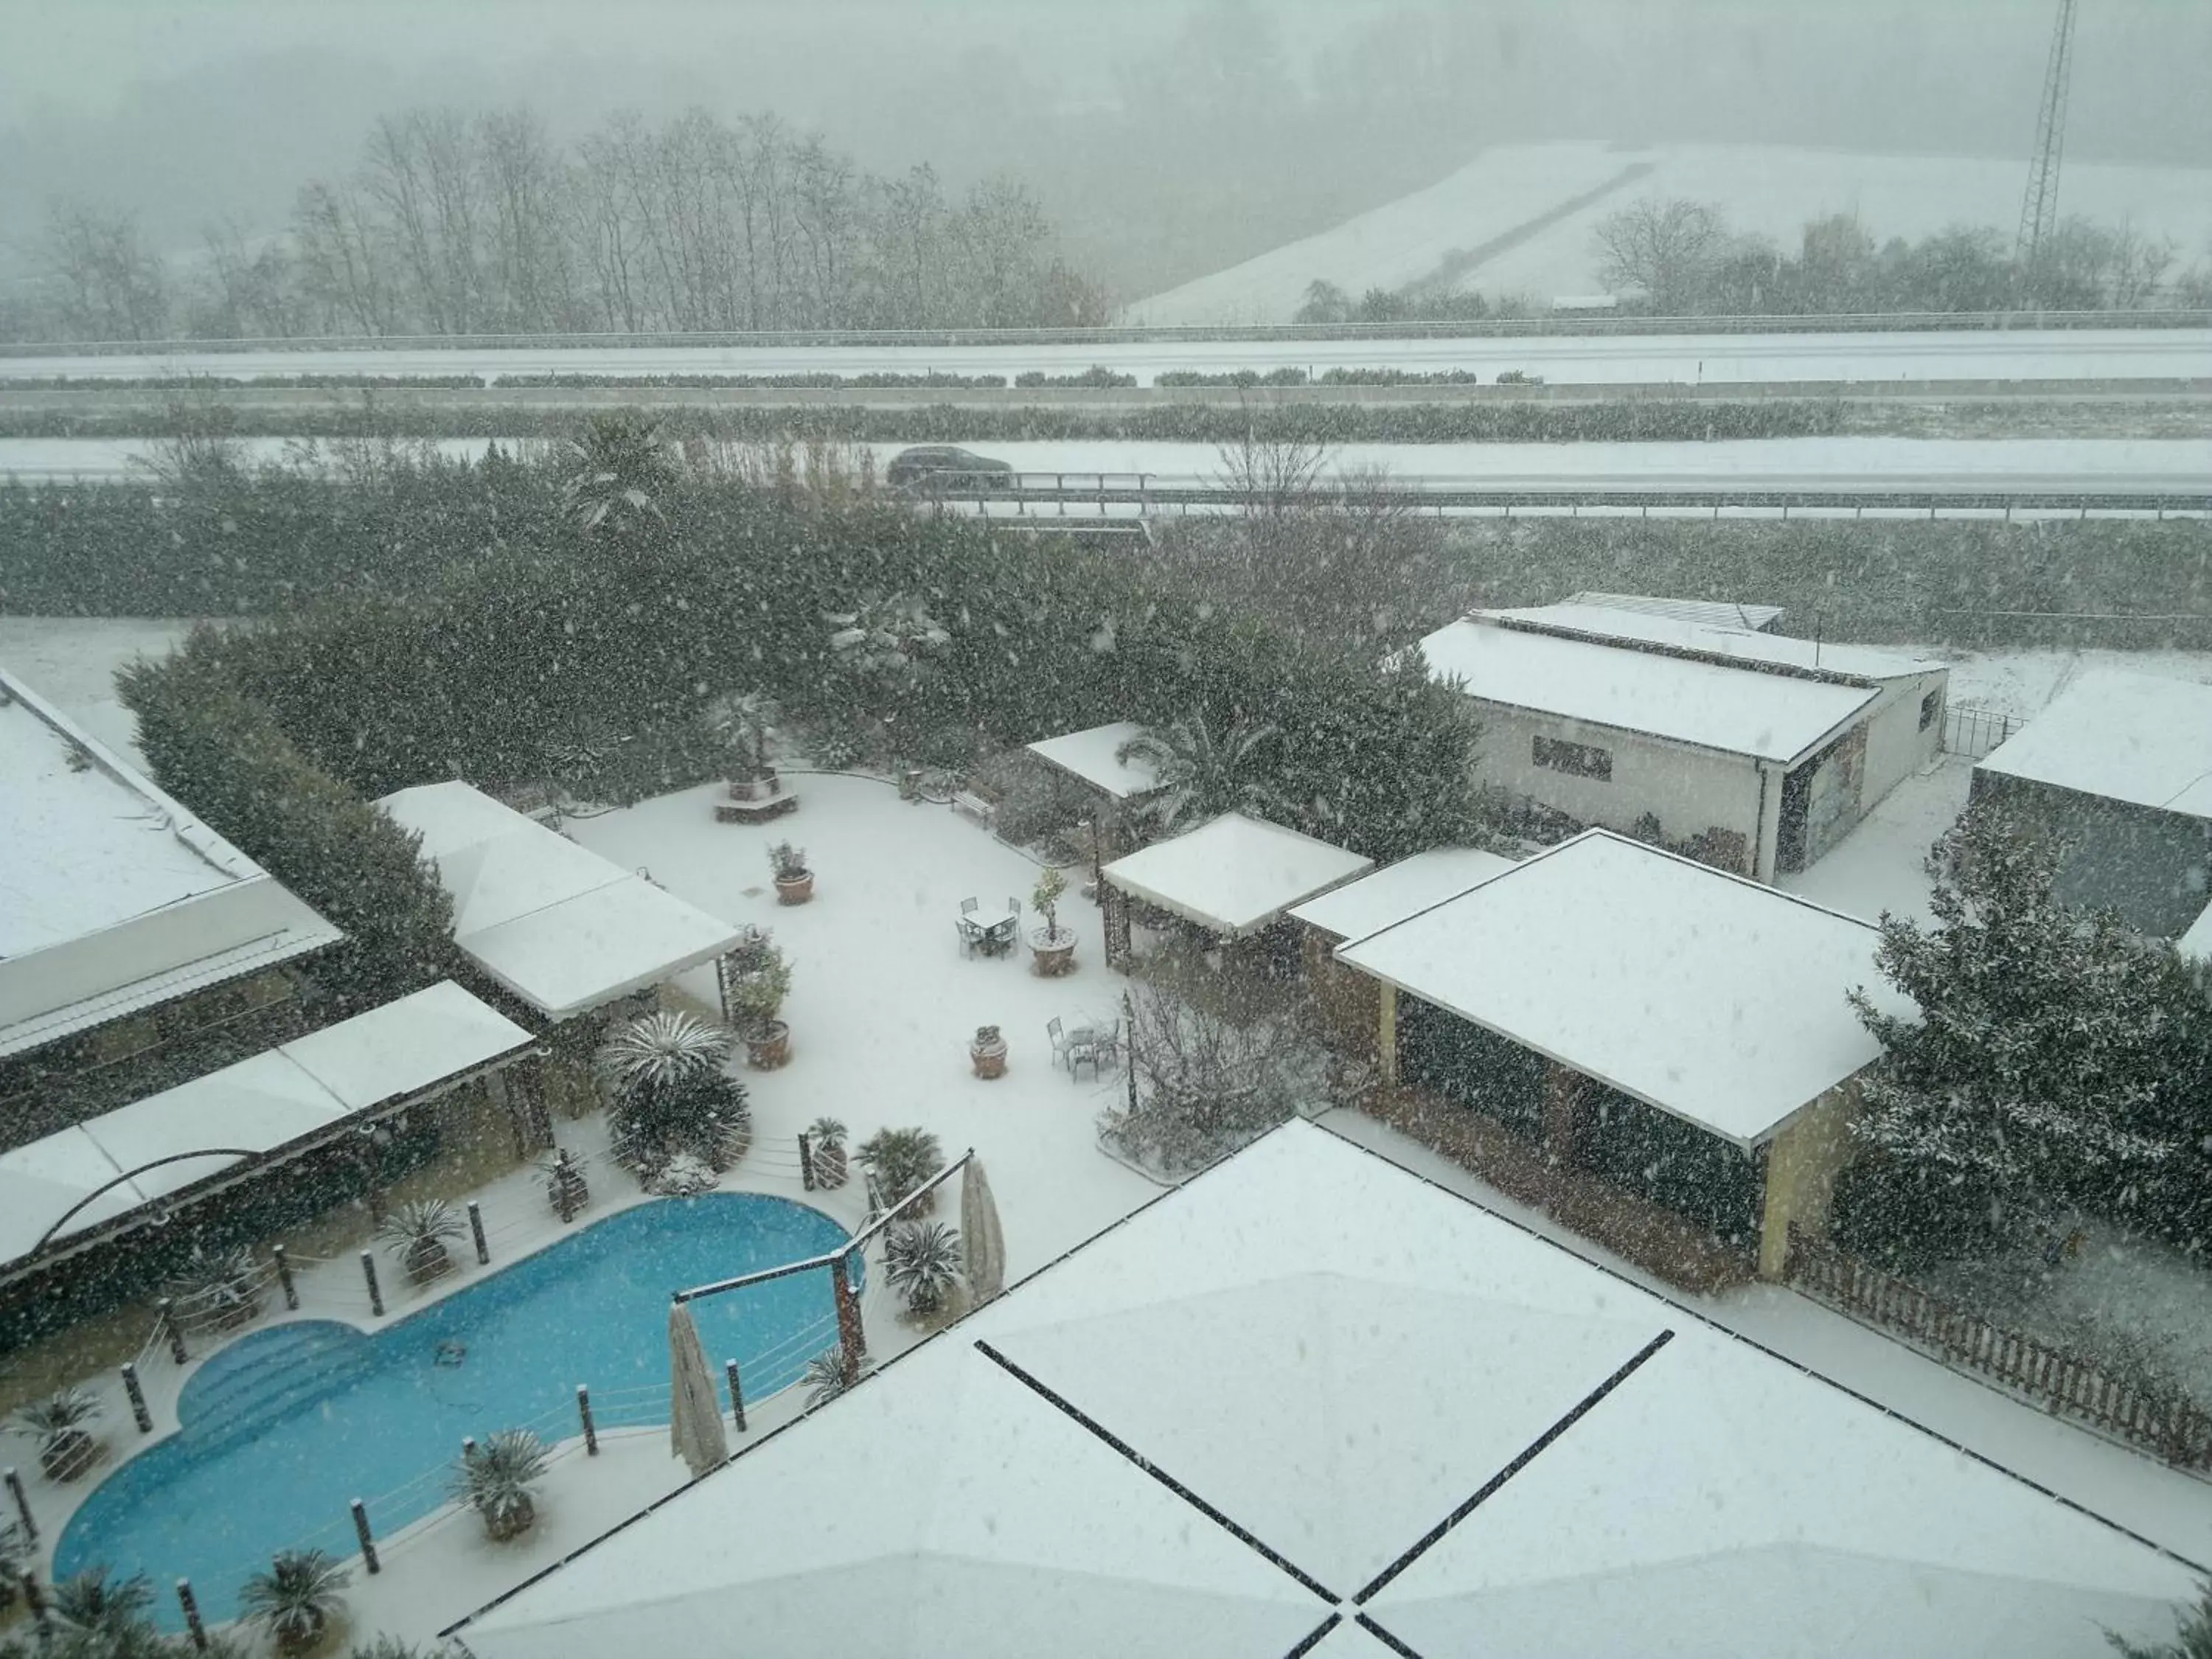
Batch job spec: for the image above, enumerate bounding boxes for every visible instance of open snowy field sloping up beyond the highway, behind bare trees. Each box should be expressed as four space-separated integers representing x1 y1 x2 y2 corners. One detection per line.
1130 144 2212 325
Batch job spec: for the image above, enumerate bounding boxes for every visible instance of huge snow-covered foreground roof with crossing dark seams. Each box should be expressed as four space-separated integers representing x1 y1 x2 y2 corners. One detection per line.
456 1121 2194 1659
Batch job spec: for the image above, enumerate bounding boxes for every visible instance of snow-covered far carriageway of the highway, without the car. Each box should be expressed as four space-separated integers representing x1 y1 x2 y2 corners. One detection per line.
13 327 2212 387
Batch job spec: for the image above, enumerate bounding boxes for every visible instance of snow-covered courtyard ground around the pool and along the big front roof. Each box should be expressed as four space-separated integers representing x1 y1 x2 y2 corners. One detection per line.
4 772 2212 1641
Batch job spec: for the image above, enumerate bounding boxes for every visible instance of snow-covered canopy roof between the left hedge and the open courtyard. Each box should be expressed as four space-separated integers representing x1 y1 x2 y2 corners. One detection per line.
376 781 739 1020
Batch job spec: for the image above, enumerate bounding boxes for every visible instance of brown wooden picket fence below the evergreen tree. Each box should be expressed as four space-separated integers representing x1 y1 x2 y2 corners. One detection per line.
1787 1225 2212 1469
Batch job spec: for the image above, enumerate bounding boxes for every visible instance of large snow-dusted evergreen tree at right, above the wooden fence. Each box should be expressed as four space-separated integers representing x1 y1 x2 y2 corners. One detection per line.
1851 807 2212 1212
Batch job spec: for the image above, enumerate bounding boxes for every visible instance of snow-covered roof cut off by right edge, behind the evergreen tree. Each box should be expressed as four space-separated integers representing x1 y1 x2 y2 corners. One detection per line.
1975 670 2212 818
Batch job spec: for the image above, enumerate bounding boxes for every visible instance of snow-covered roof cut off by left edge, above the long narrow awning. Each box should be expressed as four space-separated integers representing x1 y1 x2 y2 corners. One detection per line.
0 672 343 1055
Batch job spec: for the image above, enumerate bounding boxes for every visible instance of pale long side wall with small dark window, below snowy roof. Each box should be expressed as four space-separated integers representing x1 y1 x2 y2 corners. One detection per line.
1471 697 1759 876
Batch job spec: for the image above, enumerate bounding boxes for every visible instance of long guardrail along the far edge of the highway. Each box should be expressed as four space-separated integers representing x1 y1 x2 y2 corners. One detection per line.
0 310 2212 358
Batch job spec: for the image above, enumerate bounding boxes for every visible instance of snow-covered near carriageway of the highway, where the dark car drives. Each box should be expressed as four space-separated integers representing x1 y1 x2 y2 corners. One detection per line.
0 438 2212 498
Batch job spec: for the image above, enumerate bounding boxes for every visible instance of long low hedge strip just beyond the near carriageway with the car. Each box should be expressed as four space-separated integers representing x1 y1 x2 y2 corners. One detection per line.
0 398 1849 445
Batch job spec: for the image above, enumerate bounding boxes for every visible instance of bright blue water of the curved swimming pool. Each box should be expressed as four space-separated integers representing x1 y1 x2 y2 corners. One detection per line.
55 1192 858 1630
